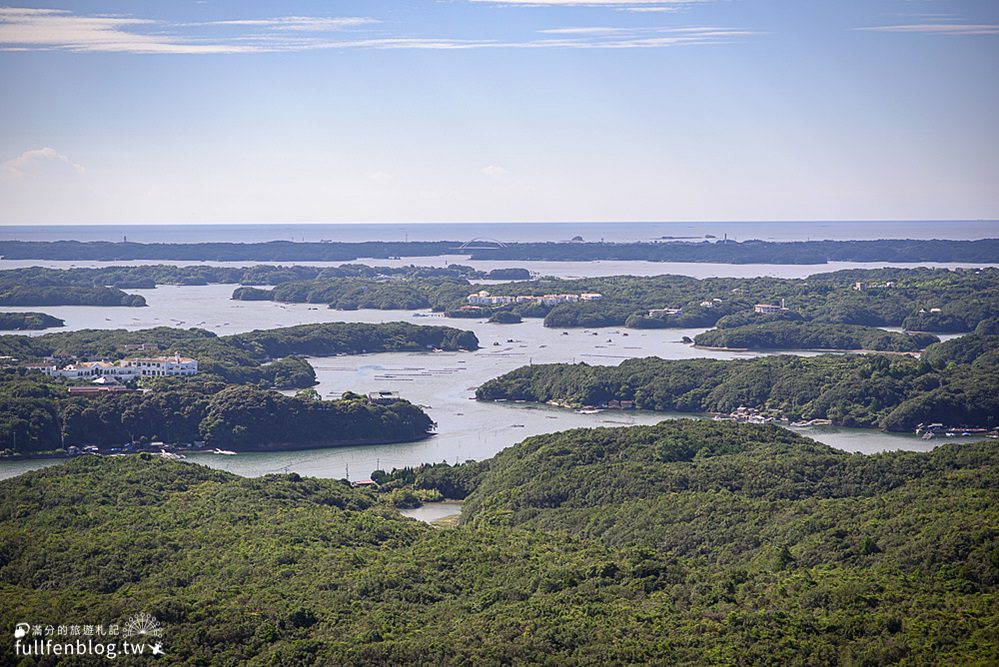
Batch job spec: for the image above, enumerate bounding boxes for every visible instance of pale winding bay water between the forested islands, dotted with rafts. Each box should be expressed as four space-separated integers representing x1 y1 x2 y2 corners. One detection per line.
0 263 976 480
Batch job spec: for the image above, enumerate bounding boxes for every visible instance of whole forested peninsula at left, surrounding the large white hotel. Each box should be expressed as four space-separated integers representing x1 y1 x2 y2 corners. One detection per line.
0 322 478 455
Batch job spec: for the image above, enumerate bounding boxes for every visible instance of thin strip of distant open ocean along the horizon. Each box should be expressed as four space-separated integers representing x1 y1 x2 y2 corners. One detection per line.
0 220 999 243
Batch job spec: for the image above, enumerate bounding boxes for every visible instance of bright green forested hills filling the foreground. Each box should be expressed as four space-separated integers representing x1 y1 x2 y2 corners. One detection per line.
0 420 999 667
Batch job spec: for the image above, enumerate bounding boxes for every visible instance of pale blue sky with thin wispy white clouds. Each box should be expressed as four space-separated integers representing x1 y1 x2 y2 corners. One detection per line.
0 0 999 224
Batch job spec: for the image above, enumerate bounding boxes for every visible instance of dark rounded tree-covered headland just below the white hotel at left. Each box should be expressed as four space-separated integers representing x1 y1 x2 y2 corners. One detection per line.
0 378 433 456
